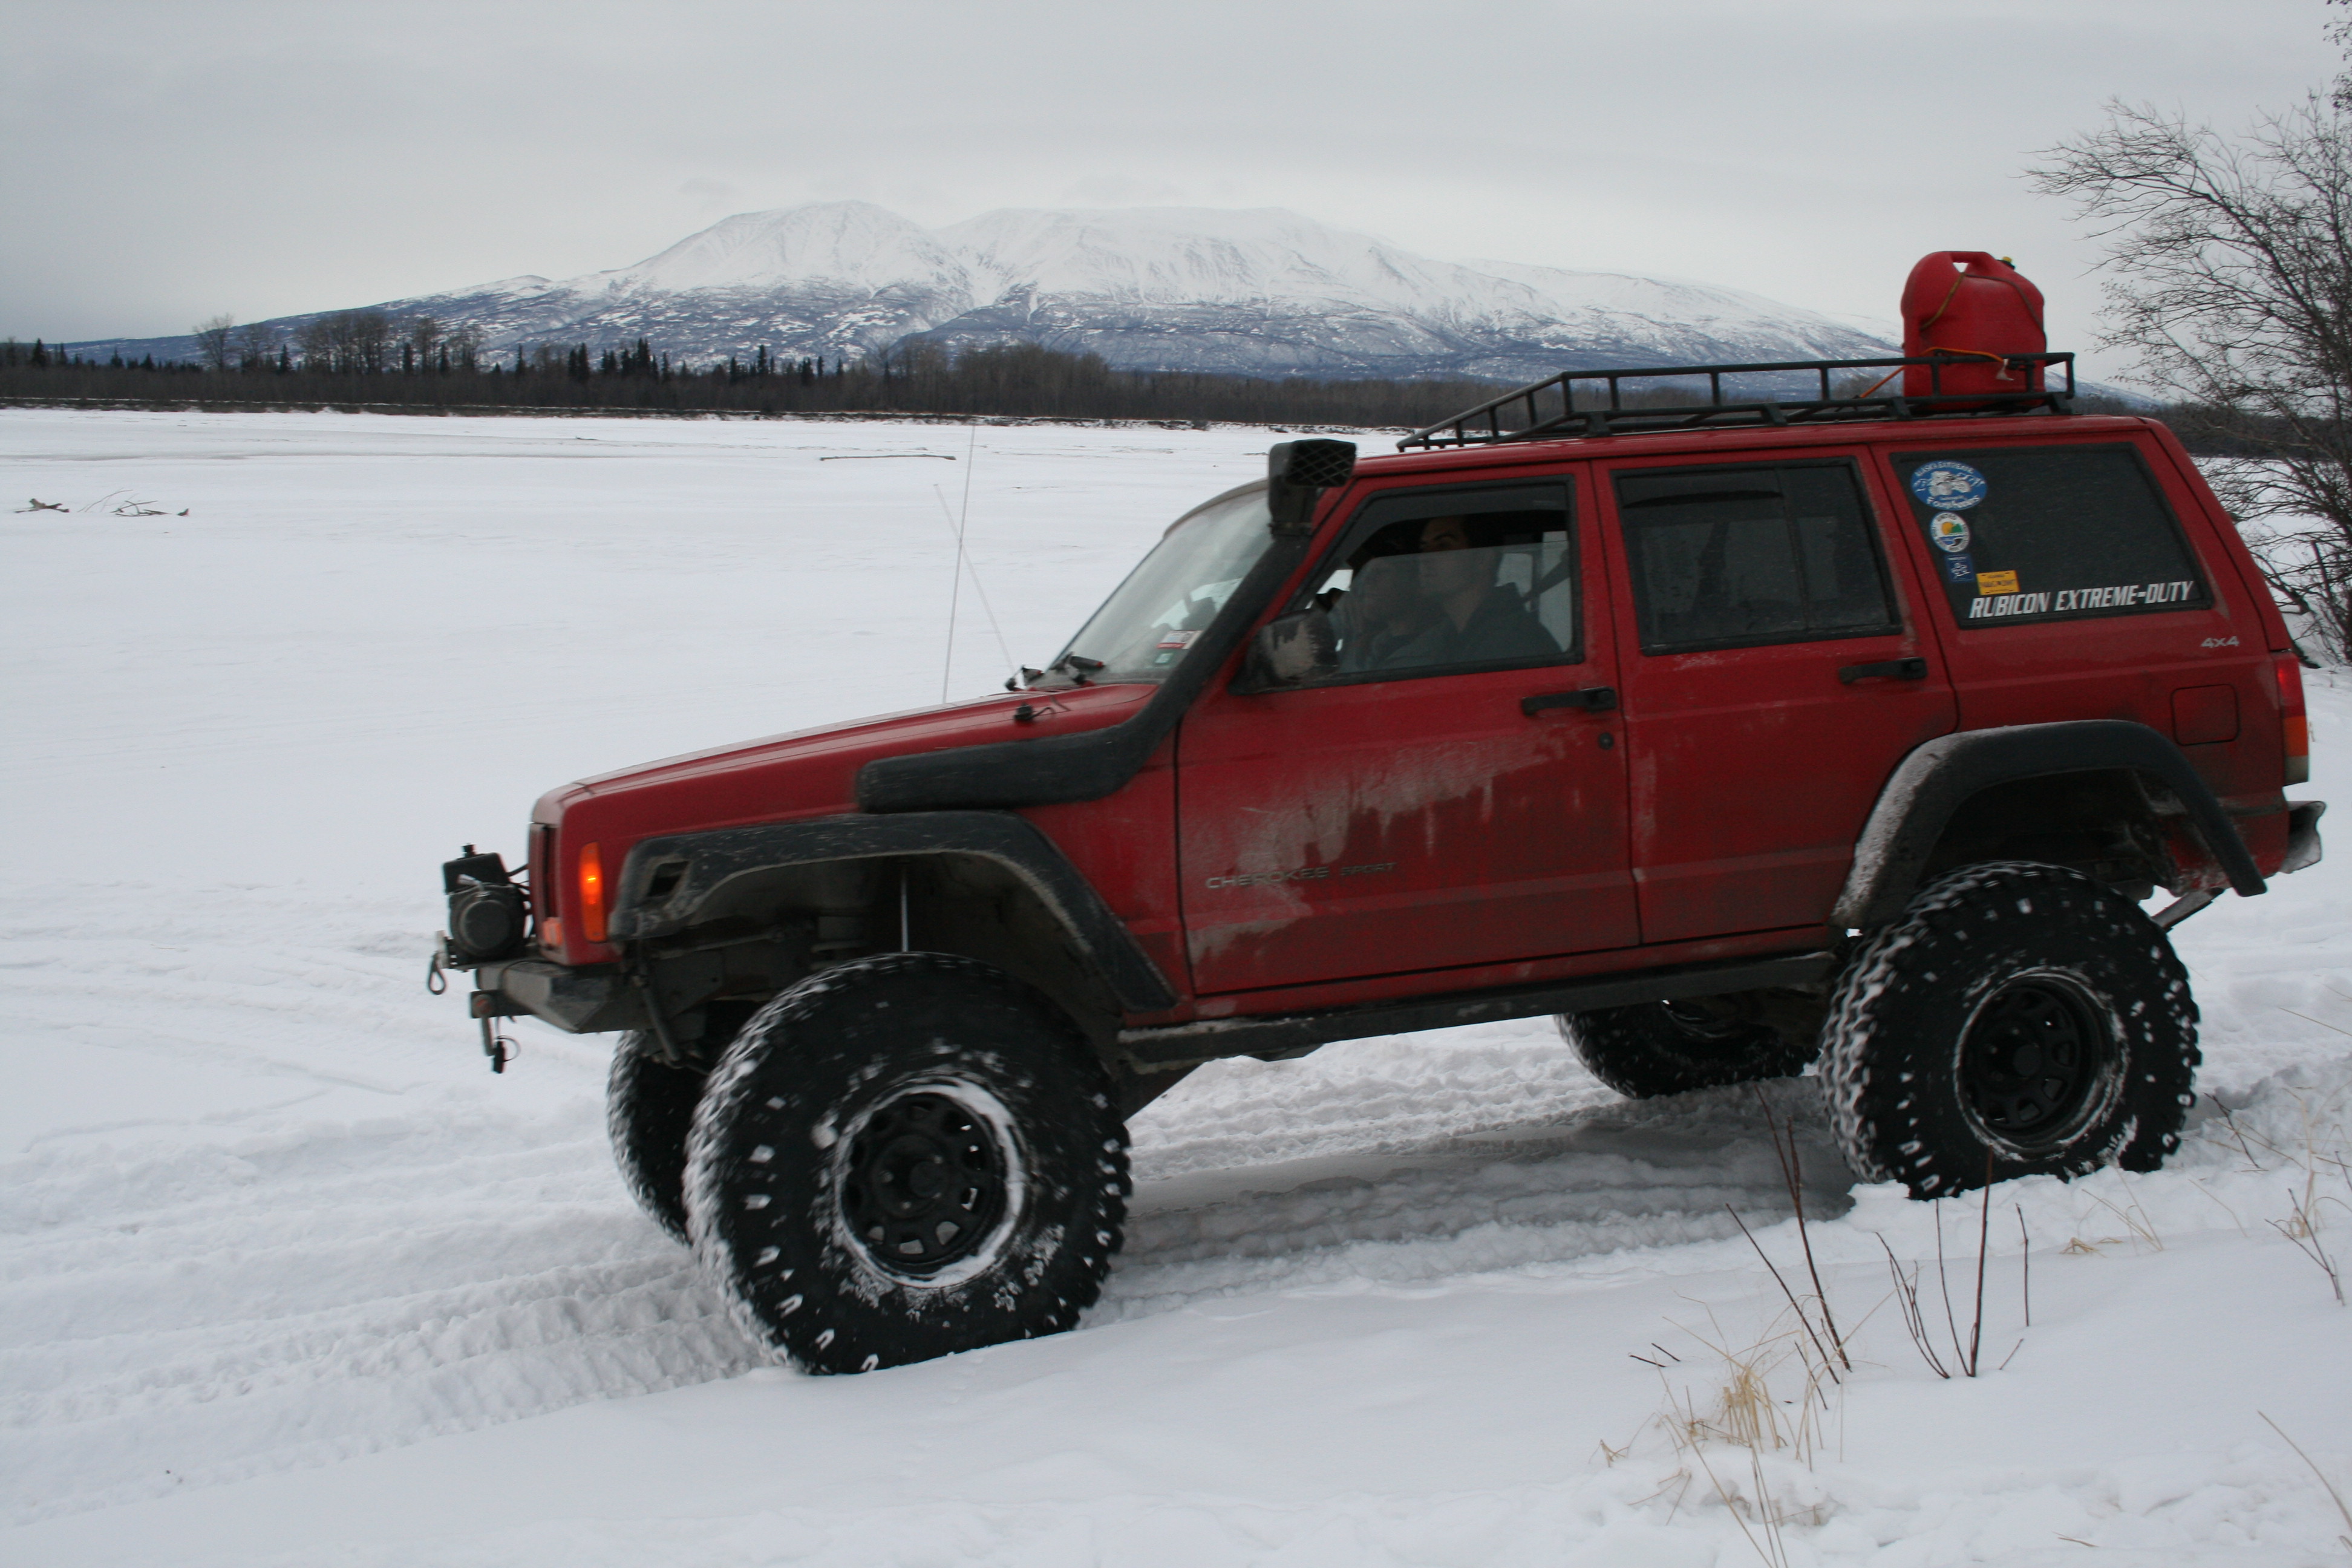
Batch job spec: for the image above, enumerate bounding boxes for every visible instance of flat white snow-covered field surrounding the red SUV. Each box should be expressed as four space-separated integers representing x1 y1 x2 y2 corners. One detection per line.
0 409 2352 1568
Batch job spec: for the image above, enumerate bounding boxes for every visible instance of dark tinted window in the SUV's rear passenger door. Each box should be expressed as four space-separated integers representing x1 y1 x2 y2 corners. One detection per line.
1616 463 1901 653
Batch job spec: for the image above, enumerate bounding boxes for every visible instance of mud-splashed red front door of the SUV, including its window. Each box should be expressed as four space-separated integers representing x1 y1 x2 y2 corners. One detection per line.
1178 472 1637 995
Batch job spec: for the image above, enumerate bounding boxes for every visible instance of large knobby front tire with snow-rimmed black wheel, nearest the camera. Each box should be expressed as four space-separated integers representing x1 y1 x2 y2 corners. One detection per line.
687 952 1129 1373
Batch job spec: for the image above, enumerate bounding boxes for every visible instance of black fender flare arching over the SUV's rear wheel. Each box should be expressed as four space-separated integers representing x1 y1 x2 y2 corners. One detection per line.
1830 719 2267 931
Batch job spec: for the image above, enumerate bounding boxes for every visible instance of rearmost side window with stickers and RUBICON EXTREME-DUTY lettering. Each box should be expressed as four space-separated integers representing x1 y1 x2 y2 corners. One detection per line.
1896 444 2213 628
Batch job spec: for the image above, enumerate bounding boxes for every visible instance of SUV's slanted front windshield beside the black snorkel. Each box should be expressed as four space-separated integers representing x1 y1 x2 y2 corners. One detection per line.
1044 485 1275 684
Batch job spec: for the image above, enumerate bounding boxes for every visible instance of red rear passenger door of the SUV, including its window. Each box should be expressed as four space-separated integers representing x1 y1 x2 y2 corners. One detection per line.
1599 449 1955 942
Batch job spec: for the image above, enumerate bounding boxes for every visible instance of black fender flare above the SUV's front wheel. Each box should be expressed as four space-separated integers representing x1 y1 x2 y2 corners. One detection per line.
609 811 1176 1013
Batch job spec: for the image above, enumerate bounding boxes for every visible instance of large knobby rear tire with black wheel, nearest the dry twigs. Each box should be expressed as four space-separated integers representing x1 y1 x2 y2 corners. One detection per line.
1820 860 2199 1199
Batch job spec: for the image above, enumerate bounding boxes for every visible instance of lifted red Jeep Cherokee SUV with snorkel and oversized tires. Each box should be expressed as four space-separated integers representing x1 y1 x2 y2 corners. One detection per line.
440 355 2321 1371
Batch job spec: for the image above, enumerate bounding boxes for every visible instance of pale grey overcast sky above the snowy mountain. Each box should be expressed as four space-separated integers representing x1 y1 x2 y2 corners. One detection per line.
0 0 2342 369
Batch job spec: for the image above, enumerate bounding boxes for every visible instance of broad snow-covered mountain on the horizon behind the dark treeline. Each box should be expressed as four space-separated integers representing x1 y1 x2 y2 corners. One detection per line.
73 202 1891 381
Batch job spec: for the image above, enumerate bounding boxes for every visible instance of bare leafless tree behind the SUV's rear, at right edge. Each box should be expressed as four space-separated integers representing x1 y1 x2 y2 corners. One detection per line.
2030 94 2352 661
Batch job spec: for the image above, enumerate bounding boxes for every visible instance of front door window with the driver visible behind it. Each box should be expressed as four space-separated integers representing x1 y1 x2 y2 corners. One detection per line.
1268 482 1583 687
